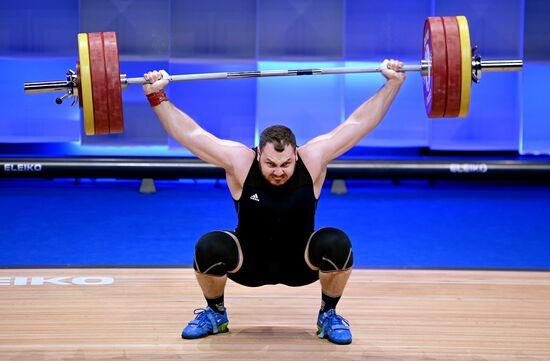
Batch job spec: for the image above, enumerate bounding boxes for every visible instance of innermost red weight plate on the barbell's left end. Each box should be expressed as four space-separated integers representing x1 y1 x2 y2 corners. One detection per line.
103 32 124 133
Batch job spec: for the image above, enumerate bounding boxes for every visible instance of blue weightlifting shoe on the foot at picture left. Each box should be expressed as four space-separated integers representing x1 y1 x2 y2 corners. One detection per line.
181 307 229 339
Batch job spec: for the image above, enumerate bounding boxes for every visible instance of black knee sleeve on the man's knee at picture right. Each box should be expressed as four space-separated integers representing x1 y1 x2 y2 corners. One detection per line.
307 228 353 272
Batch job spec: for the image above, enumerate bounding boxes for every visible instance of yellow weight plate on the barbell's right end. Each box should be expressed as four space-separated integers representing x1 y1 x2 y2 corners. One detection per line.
456 16 472 118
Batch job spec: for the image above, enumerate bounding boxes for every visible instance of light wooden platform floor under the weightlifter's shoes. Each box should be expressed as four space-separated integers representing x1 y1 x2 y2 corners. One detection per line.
0 268 550 361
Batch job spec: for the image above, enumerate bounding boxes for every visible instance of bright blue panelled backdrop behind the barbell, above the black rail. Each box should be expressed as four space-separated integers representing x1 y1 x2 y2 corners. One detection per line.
0 0 550 156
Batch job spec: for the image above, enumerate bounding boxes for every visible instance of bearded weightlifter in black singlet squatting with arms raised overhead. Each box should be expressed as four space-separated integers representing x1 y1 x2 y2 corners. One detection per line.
143 60 405 344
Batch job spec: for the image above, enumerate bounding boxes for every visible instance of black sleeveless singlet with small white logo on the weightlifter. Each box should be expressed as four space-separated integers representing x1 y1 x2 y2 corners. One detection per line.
228 148 318 286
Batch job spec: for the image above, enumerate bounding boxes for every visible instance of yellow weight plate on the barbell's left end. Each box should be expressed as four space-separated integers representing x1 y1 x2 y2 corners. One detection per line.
78 33 95 135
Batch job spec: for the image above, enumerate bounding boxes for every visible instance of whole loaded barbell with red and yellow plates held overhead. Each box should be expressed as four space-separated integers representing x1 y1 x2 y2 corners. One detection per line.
24 16 523 135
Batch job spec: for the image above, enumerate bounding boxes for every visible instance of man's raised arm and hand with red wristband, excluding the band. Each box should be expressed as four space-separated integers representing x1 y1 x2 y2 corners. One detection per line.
143 70 250 172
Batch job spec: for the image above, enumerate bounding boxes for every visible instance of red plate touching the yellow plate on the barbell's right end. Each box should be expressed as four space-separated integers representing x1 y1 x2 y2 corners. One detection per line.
443 16 462 118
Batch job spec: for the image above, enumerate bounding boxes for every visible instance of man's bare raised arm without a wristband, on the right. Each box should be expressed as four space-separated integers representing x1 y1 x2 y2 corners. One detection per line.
302 60 405 165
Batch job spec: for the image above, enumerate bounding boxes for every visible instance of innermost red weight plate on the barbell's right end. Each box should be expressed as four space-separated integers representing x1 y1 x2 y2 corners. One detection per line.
422 17 447 118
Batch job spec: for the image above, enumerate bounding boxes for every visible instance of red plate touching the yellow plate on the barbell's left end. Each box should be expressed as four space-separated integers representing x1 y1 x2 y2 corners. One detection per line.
88 33 109 134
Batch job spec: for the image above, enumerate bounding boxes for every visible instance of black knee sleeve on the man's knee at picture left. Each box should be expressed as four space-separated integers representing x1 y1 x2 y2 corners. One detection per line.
193 231 240 276
